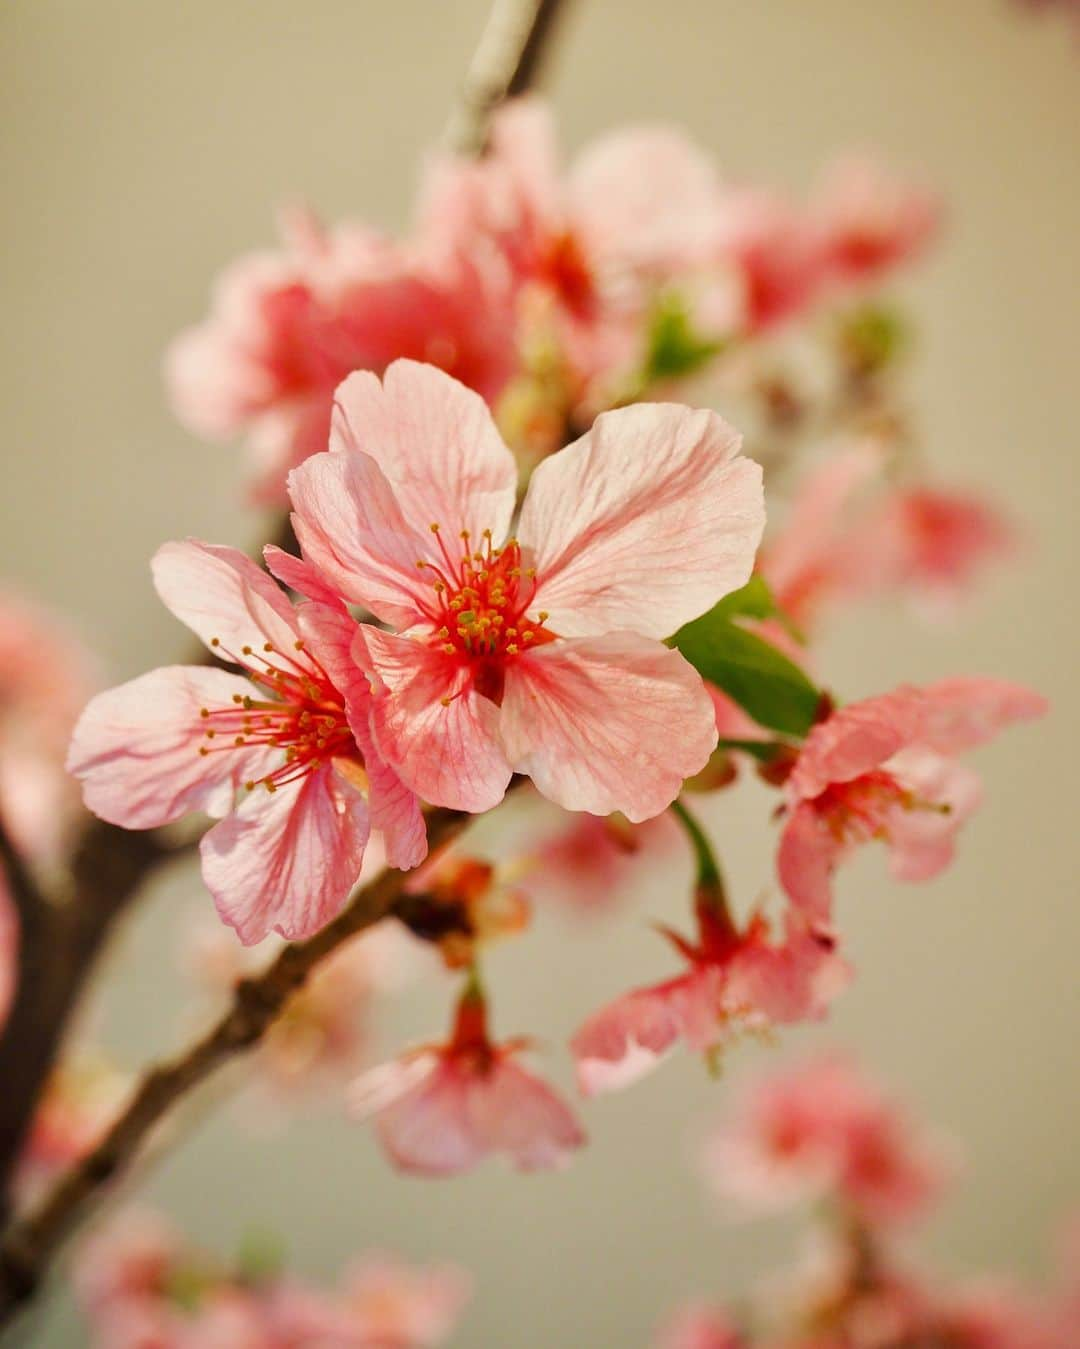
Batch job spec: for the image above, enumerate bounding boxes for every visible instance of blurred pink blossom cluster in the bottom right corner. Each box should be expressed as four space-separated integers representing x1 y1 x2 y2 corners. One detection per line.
655 1054 1080 1349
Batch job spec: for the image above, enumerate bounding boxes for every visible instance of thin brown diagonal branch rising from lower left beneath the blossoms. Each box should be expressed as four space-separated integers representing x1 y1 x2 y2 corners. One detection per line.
0 811 471 1327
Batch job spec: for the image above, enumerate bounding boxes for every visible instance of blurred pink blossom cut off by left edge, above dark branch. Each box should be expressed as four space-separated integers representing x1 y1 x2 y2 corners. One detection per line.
0 588 97 865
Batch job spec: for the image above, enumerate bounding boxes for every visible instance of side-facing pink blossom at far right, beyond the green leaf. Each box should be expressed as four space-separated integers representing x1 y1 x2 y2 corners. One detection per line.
777 679 1046 925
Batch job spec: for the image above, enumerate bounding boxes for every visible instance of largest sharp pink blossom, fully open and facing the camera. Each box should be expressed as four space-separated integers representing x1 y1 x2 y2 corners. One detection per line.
290 362 763 822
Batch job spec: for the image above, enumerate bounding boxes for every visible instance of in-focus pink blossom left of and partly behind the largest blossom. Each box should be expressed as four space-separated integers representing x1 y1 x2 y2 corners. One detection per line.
69 541 426 944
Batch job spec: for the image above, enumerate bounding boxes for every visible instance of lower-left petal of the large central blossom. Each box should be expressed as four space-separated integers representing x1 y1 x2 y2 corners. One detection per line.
355 625 512 813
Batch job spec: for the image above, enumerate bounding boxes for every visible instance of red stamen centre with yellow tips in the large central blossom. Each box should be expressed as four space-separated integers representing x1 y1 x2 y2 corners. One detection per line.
417 525 556 701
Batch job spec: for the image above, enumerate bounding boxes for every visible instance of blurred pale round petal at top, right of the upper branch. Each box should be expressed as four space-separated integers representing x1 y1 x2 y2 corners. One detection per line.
566 127 719 277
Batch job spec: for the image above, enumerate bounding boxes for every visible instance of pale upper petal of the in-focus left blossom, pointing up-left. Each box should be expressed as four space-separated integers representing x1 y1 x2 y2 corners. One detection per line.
151 538 297 658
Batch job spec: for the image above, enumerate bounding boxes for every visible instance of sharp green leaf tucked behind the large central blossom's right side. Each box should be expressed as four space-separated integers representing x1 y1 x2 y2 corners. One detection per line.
670 601 821 737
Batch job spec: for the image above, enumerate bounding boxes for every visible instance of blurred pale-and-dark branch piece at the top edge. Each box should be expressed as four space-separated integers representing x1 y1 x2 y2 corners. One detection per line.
446 0 568 154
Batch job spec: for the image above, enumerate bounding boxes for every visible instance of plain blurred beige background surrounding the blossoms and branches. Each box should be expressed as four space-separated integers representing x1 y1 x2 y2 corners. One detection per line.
0 0 1080 1349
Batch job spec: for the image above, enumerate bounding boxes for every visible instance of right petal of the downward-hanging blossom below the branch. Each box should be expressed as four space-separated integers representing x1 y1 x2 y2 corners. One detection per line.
469 1058 585 1171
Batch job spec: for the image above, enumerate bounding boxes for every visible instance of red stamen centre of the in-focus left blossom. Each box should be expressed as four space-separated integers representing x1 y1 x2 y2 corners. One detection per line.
200 637 364 792
